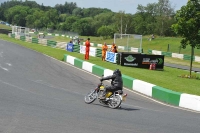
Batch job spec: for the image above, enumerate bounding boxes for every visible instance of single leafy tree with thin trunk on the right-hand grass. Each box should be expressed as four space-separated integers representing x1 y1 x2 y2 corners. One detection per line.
172 0 200 77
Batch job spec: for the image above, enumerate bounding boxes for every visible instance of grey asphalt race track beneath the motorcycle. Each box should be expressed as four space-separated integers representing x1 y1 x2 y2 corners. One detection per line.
0 40 200 133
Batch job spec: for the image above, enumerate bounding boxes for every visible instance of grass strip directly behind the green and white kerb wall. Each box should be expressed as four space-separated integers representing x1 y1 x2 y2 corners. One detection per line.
0 34 200 95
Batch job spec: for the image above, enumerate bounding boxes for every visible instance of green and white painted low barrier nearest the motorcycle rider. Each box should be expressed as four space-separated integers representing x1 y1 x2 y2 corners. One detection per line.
64 54 200 111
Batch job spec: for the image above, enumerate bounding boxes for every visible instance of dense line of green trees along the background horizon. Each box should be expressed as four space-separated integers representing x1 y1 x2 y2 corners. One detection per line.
0 0 176 39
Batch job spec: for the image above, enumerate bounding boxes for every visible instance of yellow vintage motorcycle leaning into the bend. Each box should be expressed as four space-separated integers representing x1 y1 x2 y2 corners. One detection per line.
85 81 127 109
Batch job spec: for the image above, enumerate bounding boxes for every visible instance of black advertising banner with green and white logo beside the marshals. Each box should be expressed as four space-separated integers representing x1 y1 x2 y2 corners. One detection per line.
119 53 164 69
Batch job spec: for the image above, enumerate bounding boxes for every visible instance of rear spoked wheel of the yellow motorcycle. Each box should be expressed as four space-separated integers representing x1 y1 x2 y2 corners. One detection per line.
108 95 122 109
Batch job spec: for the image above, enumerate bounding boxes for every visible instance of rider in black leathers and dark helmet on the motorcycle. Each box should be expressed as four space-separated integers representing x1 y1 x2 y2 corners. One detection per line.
100 69 123 100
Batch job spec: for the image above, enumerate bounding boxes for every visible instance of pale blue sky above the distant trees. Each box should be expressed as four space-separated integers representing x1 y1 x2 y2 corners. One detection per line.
30 0 188 14
